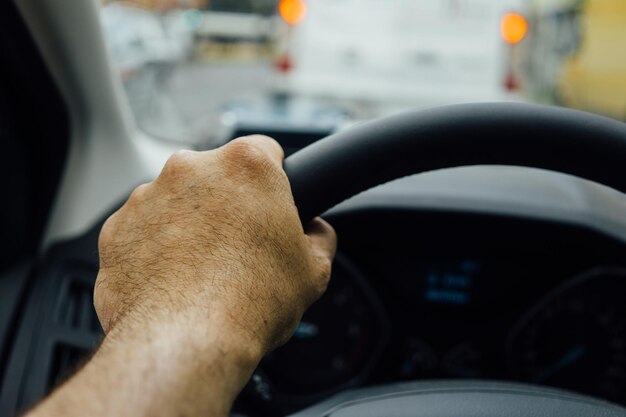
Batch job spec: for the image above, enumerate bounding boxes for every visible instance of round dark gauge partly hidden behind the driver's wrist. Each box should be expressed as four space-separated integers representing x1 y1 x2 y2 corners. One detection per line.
261 252 387 397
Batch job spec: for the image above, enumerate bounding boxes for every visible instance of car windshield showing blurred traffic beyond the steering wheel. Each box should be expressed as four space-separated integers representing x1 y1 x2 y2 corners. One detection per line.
100 0 626 147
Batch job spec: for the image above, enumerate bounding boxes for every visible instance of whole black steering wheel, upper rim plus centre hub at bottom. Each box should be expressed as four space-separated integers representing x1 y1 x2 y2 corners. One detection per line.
284 103 626 417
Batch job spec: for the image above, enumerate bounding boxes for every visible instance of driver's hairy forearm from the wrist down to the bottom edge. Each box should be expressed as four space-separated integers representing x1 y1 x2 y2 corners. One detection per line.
28 313 262 417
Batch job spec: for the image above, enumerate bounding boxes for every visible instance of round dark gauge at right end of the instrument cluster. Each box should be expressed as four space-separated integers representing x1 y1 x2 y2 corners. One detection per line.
508 270 626 403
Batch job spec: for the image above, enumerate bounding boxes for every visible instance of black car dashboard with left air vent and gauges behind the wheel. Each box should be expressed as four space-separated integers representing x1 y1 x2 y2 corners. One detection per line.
0 167 626 416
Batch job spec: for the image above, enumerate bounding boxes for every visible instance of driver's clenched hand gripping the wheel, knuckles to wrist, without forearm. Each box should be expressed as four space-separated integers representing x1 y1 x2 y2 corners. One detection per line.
94 137 335 350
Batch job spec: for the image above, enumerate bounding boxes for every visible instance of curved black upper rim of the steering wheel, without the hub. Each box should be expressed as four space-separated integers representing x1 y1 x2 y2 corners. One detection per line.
284 103 626 222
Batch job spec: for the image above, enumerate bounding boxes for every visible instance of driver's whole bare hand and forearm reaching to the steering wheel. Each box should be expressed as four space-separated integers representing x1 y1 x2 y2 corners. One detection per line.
28 136 336 416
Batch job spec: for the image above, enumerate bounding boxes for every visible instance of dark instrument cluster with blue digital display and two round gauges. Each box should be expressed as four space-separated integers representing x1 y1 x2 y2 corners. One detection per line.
260 210 626 405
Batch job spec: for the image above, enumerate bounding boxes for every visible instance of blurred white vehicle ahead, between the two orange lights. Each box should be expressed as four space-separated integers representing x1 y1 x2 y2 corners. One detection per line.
282 0 525 111
